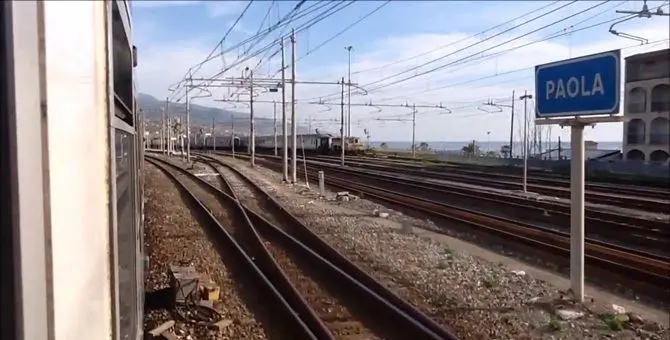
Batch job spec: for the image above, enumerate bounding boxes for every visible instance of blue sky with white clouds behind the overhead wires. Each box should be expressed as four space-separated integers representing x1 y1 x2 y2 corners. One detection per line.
132 0 670 141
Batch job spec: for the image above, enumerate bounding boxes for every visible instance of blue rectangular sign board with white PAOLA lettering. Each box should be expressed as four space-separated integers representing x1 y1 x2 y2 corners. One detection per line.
535 50 621 118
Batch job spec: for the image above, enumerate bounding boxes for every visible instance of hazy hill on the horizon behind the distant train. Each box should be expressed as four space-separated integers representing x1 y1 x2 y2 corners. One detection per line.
138 93 314 136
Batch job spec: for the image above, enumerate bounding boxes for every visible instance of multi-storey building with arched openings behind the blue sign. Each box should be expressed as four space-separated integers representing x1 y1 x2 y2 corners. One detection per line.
623 49 670 163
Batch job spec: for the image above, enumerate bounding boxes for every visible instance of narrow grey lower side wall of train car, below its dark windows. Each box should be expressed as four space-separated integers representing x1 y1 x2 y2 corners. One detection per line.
114 129 138 339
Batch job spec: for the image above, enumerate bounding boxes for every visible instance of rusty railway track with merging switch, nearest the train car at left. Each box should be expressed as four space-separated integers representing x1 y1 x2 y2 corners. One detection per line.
151 157 462 339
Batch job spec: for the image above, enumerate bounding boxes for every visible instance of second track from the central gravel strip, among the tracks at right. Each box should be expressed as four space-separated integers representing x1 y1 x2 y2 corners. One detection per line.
215 151 670 252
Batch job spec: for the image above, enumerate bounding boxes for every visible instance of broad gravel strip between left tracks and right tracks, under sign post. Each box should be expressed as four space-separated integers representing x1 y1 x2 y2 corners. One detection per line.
218 158 669 339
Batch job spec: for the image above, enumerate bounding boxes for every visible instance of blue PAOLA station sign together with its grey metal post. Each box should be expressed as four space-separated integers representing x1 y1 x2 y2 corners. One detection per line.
535 50 622 302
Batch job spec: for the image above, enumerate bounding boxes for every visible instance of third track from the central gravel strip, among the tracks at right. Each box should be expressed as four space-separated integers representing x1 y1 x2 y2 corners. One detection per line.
311 156 670 214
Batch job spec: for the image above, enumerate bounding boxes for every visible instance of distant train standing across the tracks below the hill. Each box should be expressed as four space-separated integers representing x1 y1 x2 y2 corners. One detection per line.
149 134 365 155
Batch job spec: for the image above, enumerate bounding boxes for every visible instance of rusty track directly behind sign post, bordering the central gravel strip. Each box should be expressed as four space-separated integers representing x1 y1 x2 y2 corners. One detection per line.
217 151 670 294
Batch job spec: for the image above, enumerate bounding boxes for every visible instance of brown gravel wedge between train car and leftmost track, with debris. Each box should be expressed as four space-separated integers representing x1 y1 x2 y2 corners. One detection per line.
144 163 266 339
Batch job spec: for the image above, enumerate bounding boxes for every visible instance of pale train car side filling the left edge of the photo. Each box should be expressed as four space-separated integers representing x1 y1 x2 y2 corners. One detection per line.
0 0 144 340
